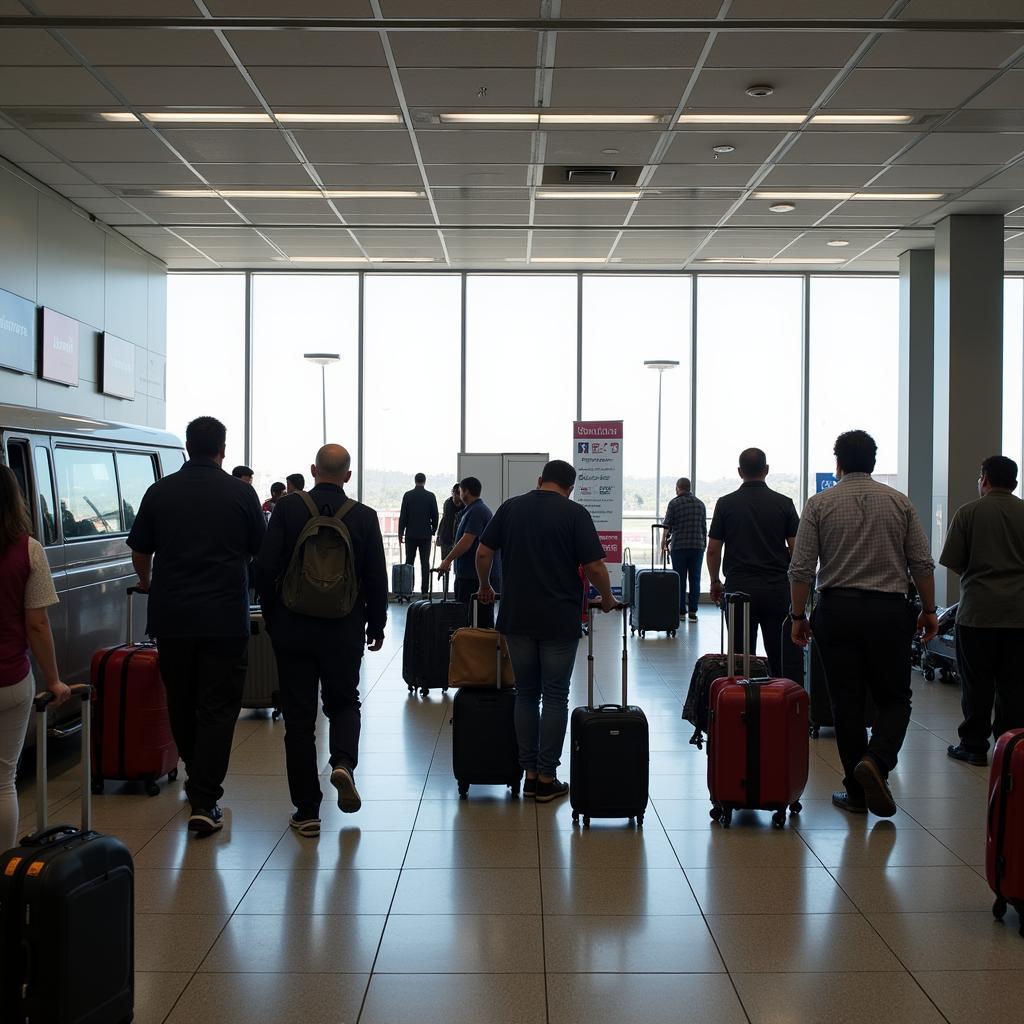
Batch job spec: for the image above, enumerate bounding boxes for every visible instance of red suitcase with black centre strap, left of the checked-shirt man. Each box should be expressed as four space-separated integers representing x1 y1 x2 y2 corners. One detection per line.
708 594 810 828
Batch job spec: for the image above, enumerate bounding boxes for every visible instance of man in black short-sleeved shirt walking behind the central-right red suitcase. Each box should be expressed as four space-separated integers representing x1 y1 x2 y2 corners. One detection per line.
708 449 804 683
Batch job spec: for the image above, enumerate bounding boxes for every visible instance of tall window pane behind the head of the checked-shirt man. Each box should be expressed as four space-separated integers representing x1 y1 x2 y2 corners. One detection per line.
807 276 899 495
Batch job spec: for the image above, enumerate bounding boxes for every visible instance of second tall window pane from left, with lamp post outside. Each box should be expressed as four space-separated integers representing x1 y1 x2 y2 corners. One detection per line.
248 273 358 500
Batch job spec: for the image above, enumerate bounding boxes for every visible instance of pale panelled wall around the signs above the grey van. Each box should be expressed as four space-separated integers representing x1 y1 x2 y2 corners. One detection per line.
0 164 167 427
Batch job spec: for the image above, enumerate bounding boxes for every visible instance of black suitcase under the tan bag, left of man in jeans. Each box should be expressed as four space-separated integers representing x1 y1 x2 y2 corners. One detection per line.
452 597 522 800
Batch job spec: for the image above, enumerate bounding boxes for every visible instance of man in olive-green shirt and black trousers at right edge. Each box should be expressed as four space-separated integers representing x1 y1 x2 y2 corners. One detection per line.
939 455 1024 765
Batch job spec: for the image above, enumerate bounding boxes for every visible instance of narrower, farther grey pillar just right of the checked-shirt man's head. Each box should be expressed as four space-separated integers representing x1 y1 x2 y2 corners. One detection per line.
898 249 935 529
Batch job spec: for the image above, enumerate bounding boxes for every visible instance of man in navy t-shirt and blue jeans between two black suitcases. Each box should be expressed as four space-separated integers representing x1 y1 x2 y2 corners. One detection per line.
477 460 621 803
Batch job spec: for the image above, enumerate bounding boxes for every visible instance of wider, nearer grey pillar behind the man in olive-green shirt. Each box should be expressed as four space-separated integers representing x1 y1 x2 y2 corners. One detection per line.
932 214 1004 604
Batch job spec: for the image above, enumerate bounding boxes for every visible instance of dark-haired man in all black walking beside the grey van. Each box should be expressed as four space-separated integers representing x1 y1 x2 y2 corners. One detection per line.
128 416 266 838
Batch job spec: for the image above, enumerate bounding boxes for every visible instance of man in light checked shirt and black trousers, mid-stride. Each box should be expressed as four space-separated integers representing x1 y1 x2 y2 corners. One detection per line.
790 430 938 817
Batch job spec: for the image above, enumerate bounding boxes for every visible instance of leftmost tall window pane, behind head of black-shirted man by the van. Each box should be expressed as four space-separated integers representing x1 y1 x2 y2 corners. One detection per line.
167 273 246 465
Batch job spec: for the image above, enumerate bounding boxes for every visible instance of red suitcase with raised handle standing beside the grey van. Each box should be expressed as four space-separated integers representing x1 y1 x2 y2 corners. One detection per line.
92 587 178 797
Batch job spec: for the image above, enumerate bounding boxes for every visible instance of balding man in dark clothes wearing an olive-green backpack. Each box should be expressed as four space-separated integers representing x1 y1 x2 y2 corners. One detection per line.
256 444 388 837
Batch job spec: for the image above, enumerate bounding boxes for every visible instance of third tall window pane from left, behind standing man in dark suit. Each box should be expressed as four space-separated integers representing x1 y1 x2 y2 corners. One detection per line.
362 274 462 575
